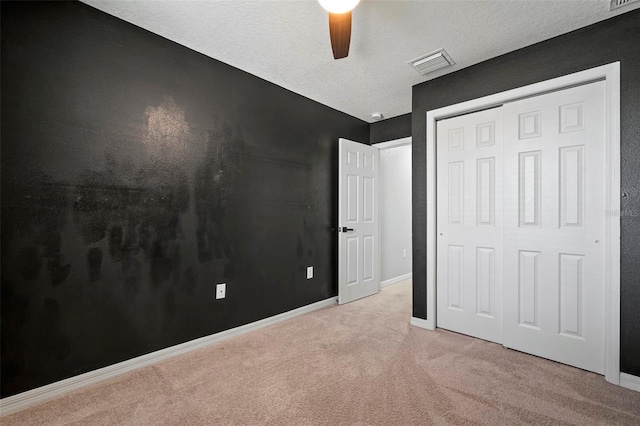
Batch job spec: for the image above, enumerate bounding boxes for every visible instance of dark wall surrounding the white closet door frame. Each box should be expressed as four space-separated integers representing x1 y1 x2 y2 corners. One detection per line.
412 10 640 376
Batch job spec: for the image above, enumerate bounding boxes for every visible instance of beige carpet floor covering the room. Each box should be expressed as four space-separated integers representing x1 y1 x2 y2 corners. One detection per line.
0 281 640 426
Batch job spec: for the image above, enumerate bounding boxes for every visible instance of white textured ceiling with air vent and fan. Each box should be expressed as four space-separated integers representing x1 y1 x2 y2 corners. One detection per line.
83 0 640 122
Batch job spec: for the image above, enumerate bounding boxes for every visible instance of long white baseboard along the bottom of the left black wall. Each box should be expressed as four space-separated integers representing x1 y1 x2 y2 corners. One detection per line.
0 297 338 415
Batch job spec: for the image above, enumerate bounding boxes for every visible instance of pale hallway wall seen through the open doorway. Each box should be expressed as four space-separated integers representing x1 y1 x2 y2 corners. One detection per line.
380 145 411 282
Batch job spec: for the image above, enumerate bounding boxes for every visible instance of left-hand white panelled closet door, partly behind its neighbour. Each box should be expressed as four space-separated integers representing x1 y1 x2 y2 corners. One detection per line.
437 108 502 342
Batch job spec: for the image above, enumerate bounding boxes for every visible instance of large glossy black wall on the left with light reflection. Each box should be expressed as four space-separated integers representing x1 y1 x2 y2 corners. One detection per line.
1 1 369 397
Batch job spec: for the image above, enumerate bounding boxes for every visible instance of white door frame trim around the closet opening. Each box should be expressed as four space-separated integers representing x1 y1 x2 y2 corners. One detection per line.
422 62 620 385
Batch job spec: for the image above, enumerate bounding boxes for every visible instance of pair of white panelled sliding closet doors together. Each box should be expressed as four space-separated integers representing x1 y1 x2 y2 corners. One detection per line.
437 82 606 373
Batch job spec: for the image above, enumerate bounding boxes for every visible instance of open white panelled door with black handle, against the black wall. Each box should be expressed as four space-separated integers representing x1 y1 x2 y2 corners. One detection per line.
338 139 380 304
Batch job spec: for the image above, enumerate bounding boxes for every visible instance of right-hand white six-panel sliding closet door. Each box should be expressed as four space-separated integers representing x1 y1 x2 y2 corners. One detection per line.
503 81 606 373
